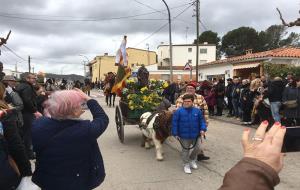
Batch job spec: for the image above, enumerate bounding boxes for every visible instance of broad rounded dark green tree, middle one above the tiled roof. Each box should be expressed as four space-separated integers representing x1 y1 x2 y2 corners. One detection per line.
221 27 260 57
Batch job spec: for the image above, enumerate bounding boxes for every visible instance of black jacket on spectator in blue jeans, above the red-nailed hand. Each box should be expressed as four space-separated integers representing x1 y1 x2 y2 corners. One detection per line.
268 80 284 102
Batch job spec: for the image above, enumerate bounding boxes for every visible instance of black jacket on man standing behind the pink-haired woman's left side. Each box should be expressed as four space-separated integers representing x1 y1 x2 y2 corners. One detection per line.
16 81 38 113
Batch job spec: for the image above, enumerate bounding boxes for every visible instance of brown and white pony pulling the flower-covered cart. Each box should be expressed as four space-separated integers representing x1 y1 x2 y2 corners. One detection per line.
139 110 173 161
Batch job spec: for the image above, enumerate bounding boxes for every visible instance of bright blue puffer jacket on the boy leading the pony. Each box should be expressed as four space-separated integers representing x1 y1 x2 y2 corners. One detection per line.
172 107 206 139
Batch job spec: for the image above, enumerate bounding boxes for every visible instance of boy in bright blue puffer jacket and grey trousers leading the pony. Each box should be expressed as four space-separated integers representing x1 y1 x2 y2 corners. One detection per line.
172 94 206 174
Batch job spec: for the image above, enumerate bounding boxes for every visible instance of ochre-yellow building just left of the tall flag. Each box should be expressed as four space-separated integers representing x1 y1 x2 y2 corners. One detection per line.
89 53 118 82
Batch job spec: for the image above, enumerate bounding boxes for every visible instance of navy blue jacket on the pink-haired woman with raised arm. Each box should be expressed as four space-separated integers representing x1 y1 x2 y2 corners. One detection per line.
32 99 109 190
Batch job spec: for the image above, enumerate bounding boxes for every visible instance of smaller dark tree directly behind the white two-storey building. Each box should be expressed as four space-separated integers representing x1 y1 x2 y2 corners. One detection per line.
194 30 221 59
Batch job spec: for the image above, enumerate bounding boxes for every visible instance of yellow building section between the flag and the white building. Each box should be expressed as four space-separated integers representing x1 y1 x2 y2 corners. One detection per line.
126 47 157 68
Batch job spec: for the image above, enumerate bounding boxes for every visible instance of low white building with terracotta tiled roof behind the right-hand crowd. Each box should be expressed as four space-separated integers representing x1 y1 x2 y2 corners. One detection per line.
199 47 300 83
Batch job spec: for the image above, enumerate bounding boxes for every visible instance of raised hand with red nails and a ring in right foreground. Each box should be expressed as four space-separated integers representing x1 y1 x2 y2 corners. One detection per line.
242 121 286 173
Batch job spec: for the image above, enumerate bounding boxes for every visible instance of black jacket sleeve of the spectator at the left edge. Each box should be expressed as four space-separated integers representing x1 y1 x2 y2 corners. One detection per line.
1 112 32 176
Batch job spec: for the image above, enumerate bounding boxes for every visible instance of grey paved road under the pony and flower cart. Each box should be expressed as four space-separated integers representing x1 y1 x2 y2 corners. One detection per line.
84 92 300 190
